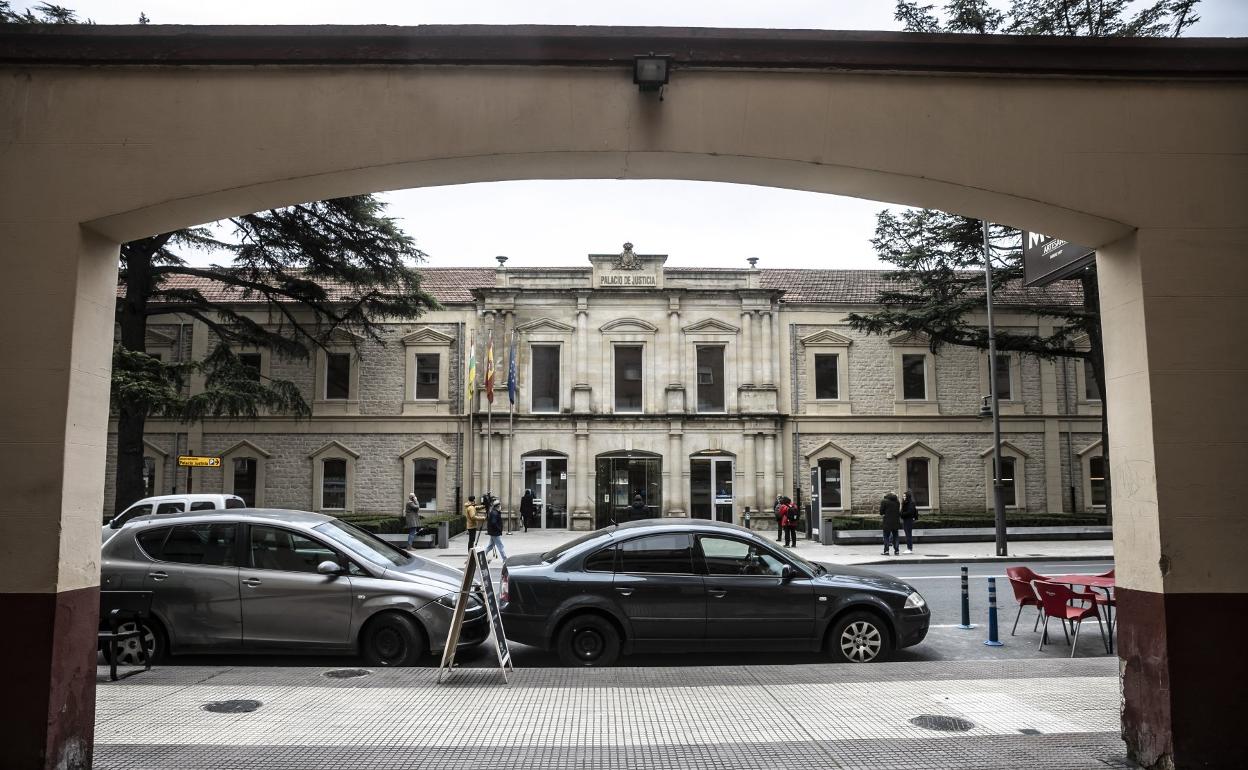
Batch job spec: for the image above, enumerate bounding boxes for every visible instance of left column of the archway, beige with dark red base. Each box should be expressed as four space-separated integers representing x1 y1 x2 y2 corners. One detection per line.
0 223 119 769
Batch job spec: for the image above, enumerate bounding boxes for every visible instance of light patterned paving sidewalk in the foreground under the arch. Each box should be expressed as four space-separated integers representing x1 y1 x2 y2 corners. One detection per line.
95 659 1132 770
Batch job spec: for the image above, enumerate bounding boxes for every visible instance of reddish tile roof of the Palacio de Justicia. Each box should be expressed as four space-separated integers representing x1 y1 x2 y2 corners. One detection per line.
134 267 1083 306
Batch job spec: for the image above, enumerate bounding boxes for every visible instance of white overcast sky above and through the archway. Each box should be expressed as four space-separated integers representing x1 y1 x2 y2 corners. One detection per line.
31 0 1248 267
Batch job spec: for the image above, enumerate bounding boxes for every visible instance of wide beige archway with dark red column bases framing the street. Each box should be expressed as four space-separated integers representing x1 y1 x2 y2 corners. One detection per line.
0 26 1248 768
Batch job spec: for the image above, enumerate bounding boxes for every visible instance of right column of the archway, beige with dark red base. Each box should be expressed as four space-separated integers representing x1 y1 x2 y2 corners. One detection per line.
1097 227 1248 768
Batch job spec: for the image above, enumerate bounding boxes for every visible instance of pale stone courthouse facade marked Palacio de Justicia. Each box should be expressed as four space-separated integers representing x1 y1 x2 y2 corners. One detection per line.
105 245 1104 529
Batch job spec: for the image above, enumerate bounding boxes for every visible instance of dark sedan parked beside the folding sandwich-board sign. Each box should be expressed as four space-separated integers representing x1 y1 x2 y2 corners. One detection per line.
500 520 931 666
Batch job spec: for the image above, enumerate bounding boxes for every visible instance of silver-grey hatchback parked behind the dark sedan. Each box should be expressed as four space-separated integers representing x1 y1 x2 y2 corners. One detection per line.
101 509 489 666
